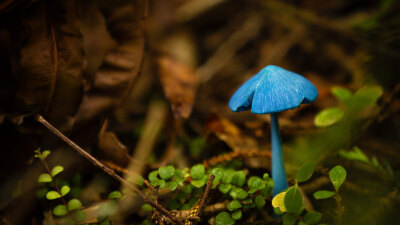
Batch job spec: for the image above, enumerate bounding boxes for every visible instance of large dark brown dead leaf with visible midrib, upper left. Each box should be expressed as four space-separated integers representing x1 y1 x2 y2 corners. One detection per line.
17 0 85 128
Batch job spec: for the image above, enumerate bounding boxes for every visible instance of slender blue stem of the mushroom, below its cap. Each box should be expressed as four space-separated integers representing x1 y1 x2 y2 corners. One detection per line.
271 113 288 196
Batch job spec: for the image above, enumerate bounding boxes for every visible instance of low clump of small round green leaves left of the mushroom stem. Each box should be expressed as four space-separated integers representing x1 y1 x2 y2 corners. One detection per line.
137 163 273 225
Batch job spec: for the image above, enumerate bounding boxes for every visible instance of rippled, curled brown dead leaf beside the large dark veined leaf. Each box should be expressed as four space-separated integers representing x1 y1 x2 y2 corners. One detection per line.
73 0 147 125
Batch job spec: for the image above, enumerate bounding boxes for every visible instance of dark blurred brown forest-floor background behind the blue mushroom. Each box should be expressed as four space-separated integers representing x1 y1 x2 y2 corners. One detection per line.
0 0 400 224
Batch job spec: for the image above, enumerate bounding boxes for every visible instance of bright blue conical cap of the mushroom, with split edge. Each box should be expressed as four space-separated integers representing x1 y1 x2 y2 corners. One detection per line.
229 65 318 114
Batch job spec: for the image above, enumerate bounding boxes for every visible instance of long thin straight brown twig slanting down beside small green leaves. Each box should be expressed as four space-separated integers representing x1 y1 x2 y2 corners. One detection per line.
36 115 184 225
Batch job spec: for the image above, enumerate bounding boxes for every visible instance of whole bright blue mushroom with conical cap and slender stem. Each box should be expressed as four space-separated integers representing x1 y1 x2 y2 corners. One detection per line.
229 65 318 196
